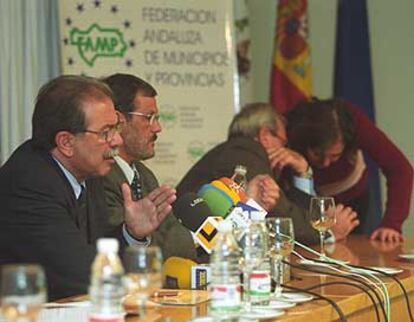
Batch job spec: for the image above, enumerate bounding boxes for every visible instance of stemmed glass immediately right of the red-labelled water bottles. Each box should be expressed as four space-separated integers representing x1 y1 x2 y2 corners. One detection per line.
266 217 295 298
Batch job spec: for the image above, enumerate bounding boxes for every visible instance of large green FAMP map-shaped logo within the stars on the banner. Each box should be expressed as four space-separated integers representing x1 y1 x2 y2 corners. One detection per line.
70 23 127 67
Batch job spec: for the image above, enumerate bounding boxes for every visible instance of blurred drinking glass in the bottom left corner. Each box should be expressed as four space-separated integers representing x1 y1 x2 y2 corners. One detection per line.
0 264 47 322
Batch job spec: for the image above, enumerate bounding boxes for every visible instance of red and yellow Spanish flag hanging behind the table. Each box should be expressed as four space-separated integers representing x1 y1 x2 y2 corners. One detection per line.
270 0 312 114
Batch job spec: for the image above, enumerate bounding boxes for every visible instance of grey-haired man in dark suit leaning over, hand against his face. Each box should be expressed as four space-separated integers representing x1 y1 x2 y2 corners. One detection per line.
177 103 356 244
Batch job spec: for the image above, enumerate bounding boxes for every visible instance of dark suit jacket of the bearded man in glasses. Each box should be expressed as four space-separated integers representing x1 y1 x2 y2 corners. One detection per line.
103 161 196 260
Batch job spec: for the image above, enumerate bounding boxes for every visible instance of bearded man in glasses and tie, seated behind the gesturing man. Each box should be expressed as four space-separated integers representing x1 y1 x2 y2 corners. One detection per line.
100 74 197 260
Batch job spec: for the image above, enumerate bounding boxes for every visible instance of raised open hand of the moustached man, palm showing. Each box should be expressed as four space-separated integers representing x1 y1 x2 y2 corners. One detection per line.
122 183 177 239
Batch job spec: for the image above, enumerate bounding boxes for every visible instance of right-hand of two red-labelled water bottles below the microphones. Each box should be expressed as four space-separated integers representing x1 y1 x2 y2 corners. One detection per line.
243 217 271 308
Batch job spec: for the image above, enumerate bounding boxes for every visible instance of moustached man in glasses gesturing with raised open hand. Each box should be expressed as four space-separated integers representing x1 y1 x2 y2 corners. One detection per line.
0 76 175 299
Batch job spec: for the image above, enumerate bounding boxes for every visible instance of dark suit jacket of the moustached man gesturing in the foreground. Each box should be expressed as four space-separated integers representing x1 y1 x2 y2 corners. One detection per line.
0 141 121 299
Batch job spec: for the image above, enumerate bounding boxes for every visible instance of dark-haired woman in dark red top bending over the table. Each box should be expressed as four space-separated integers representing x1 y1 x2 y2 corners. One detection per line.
287 99 413 241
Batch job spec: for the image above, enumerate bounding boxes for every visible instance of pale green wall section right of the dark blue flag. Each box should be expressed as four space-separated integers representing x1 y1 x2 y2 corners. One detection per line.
368 0 414 234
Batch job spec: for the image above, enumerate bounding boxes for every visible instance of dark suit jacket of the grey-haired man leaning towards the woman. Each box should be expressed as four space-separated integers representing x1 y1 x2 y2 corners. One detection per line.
177 137 318 244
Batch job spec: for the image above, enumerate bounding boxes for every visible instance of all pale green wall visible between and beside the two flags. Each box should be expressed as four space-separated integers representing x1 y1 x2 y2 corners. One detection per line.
248 0 414 234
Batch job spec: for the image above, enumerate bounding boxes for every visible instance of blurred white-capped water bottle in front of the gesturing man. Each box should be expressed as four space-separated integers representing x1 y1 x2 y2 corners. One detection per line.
89 238 125 322
